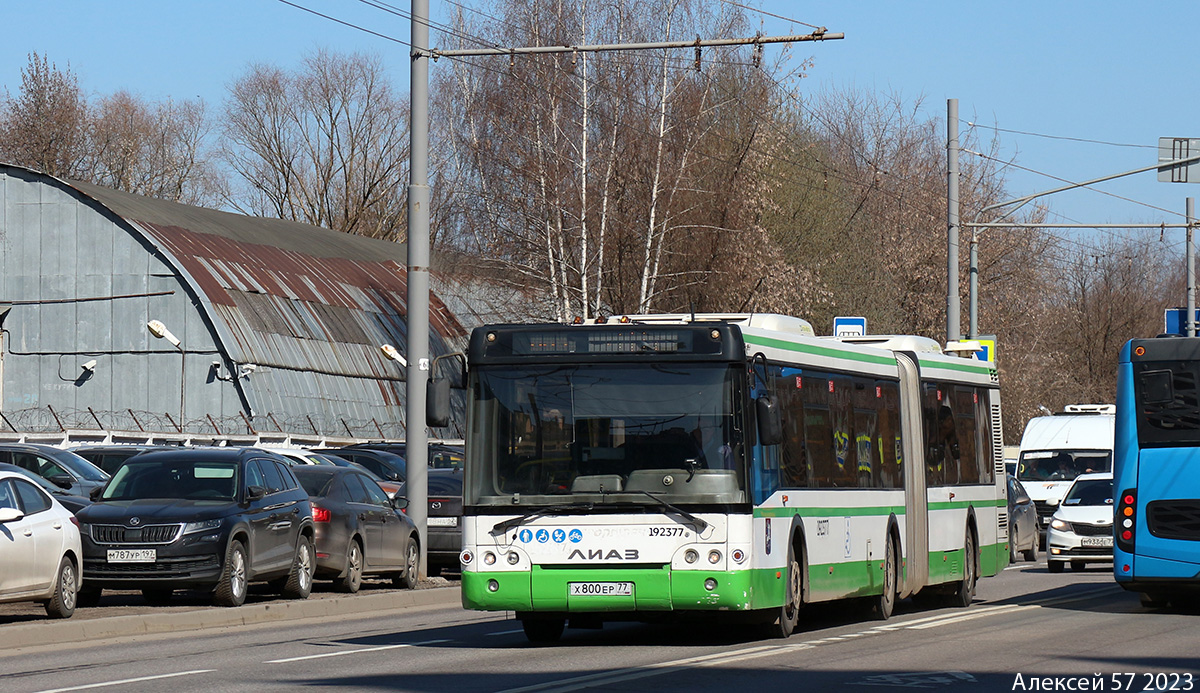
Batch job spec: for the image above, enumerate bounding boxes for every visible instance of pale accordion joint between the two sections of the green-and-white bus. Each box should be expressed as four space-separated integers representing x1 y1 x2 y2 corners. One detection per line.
895 351 929 589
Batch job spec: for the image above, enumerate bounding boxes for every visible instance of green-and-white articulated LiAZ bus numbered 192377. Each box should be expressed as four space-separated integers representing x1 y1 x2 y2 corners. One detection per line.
448 314 1008 641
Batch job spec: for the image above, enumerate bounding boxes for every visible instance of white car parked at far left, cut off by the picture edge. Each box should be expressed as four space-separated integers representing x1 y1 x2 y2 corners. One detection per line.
0 471 83 619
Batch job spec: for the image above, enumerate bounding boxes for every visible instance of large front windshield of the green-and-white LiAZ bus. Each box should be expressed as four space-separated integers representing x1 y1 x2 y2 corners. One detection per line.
464 362 746 507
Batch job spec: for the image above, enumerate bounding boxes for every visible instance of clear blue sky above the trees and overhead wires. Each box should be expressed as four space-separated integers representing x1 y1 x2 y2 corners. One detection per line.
0 0 1200 248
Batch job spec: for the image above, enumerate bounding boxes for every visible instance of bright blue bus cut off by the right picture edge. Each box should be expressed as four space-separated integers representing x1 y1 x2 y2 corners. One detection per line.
1112 337 1200 607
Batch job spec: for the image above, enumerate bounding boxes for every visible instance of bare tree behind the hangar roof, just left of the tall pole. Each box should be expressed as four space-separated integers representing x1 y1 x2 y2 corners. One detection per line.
223 52 408 241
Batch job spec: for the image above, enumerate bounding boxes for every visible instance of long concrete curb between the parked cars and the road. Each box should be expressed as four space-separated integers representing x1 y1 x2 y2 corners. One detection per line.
0 585 462 653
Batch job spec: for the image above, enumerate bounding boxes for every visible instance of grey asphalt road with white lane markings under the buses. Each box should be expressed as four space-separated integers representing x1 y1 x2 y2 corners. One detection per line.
0 562 1200 693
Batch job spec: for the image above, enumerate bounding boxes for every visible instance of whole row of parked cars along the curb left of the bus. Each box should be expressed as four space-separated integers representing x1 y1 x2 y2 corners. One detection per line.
0 444 462 617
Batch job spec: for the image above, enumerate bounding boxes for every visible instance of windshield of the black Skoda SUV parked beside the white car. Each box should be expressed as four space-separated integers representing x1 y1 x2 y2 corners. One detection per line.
101 458 240 501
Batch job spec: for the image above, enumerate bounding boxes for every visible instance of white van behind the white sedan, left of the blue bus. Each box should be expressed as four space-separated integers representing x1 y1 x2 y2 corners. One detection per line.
1016 404 1117 538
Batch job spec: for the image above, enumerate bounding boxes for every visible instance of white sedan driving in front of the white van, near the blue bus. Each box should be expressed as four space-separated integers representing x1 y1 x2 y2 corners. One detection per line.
1046 472 1112 573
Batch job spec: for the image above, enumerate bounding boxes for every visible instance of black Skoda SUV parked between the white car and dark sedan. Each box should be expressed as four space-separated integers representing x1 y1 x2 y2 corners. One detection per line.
77 447 316 607
